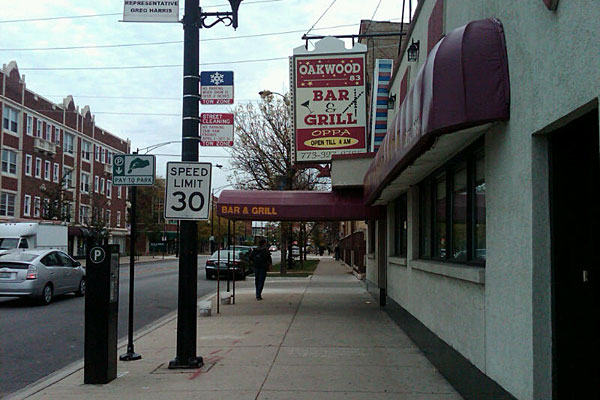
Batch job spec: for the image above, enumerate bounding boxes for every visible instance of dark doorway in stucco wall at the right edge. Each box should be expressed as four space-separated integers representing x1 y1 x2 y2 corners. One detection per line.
550 109 600 399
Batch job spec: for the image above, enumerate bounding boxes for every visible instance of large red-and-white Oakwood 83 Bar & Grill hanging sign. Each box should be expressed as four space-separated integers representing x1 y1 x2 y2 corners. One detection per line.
290 37 367 163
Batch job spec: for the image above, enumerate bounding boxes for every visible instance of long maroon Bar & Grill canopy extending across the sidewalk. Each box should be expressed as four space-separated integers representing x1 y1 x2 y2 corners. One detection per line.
217 190 384 221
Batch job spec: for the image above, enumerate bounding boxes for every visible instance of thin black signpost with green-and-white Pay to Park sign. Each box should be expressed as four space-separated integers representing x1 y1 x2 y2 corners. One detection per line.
113 154 156 361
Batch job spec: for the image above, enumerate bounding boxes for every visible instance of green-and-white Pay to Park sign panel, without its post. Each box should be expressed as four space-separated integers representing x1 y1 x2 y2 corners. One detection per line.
113 154 156 186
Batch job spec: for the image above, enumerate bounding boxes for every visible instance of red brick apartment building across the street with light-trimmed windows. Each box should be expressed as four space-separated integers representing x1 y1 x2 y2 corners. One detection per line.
0 61 130 256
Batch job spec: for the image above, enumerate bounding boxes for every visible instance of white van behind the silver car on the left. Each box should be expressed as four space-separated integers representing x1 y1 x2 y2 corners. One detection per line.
0 222 68 252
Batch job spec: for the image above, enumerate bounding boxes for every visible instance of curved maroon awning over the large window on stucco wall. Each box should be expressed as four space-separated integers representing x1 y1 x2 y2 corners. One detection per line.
364 18 510 204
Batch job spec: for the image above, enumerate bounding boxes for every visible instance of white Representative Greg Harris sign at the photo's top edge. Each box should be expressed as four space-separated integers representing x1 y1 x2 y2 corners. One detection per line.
123 0 179 22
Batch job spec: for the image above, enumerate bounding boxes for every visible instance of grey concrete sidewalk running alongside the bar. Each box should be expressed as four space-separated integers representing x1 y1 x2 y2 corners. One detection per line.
18 259 461 400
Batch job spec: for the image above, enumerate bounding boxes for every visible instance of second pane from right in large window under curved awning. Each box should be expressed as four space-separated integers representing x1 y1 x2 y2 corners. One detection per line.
452 163 467 261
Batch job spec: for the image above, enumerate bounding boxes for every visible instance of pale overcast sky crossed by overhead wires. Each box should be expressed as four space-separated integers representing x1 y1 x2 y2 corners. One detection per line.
0 0 408 194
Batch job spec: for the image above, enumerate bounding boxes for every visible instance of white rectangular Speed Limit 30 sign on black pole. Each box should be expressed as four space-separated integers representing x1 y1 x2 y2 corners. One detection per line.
165 162 212 220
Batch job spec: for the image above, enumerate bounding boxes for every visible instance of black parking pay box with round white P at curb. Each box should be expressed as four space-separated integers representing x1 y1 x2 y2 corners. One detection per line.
83 245 119 384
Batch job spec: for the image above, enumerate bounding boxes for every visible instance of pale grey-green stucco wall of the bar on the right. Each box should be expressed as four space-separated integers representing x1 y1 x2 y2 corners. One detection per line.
376 0 600 399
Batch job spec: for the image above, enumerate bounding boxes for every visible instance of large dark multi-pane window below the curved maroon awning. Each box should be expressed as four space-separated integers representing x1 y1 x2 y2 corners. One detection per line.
419 145 486 263
